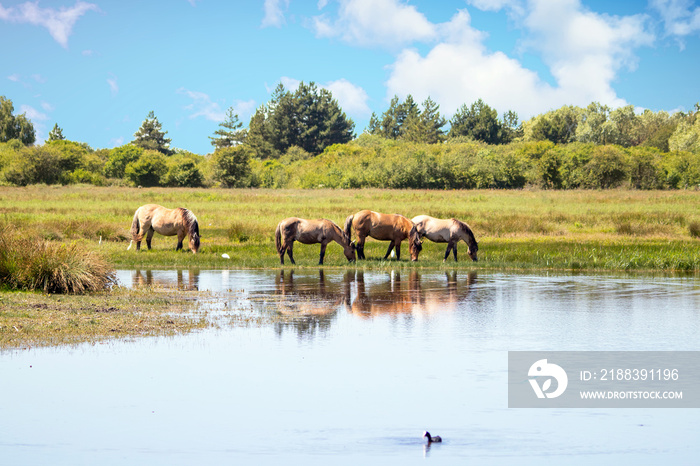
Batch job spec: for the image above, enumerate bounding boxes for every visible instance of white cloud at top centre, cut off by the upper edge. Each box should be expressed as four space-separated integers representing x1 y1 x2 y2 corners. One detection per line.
312 0 437 47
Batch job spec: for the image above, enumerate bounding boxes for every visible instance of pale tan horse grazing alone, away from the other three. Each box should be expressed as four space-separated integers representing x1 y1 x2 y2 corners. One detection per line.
127 204 200 254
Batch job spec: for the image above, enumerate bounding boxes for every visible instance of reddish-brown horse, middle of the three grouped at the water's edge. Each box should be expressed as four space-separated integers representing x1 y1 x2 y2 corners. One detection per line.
345 210 423 261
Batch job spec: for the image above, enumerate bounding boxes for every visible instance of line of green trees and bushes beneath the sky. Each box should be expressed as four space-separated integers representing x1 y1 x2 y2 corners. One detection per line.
0 82 700 189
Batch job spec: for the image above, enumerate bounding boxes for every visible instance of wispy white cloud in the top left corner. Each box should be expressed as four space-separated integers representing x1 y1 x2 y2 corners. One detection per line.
0 1 99 48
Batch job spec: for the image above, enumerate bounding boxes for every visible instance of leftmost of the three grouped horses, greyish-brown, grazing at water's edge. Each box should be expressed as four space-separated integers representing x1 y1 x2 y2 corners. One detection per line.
275 217 355 265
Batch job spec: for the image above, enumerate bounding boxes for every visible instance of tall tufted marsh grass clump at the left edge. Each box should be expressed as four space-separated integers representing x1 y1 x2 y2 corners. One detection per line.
0 226 115 294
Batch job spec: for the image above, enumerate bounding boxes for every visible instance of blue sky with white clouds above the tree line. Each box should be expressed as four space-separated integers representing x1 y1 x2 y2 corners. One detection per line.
0 0 700 154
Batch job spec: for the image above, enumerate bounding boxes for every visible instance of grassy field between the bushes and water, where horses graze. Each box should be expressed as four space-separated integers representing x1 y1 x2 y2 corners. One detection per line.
0 186 700 272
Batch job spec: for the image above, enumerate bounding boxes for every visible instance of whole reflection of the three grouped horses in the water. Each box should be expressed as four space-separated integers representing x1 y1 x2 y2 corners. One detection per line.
258 269 477 336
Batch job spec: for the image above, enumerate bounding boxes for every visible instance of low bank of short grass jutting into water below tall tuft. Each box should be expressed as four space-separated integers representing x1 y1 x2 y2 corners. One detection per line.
0 287 212 349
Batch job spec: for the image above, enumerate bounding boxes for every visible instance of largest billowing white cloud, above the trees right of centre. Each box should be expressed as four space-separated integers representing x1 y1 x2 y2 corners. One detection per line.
387 0 654 119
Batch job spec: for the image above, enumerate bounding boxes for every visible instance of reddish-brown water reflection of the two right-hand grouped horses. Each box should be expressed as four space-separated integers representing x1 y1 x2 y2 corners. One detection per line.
350 270 476 318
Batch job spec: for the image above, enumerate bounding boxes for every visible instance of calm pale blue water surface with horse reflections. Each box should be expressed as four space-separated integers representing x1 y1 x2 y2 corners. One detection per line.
0 270 700 465
